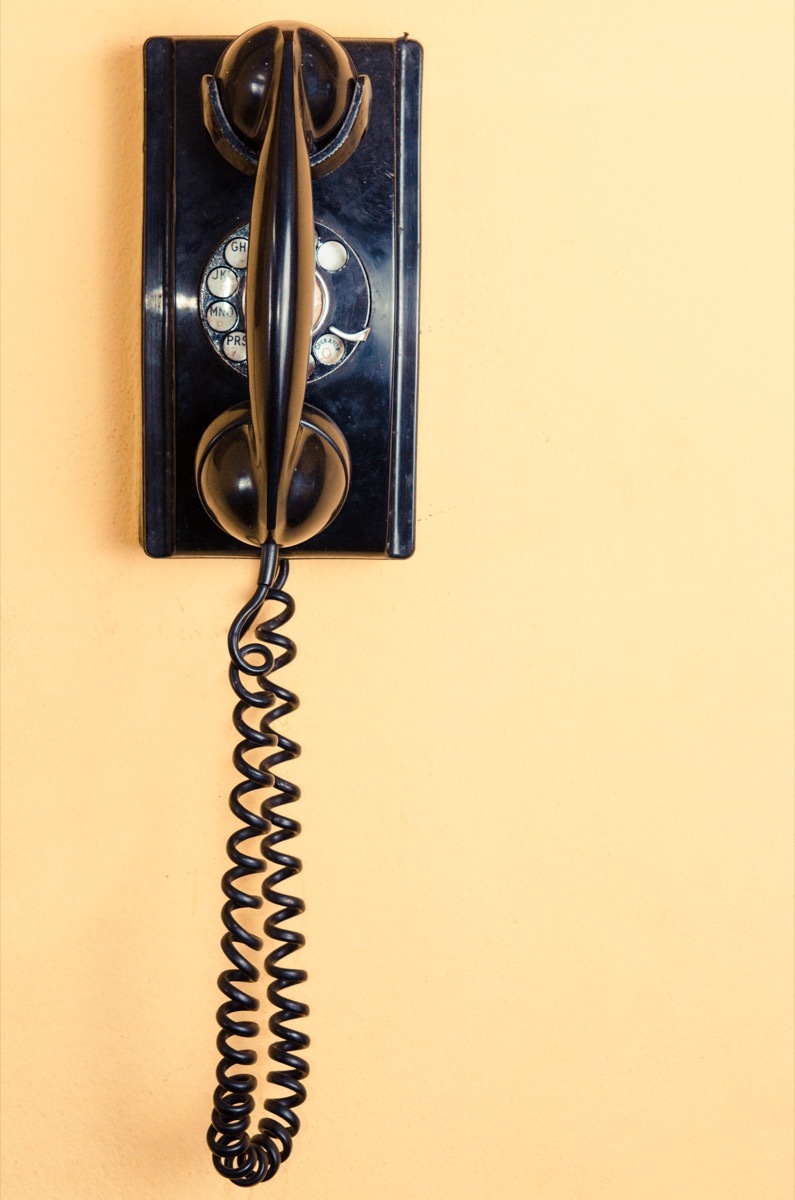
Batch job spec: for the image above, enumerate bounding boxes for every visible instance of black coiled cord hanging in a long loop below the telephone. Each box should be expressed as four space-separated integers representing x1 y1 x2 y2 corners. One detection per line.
208 542 309 1187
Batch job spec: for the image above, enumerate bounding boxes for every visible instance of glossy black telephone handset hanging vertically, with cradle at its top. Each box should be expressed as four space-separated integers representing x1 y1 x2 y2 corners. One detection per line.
196 22 370 546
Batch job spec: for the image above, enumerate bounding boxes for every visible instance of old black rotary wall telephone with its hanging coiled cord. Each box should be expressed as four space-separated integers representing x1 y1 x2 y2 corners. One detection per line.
142 22 422 1187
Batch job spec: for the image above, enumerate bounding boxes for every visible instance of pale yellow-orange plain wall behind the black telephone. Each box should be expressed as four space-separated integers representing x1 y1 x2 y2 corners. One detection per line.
2 0 793 1200
